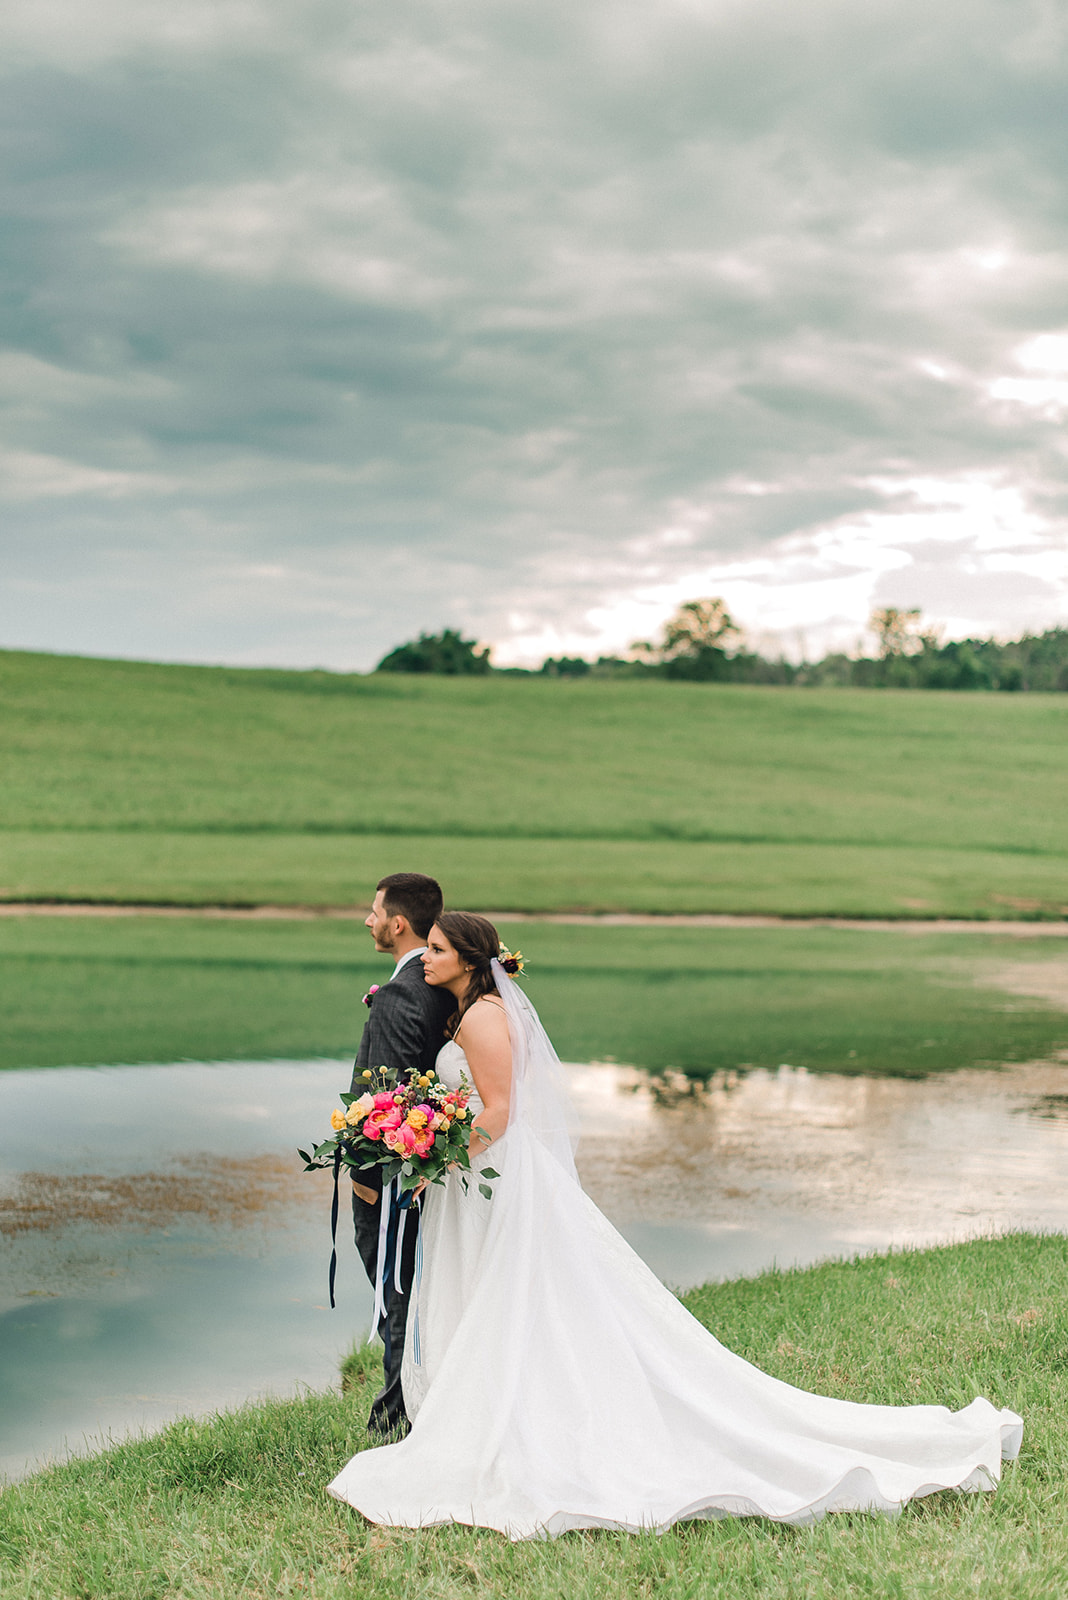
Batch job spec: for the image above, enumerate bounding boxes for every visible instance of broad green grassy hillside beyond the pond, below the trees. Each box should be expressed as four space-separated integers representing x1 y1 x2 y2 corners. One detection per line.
0 653 1068 918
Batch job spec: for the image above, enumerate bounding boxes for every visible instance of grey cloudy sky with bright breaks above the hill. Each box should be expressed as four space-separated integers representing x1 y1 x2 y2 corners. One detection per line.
0 0 1068 669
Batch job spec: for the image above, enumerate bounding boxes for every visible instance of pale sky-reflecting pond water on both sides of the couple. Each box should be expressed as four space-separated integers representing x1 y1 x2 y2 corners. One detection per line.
0 1059 1068 1477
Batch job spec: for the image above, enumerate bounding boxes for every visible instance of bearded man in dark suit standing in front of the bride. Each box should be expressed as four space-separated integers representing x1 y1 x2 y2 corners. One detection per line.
352 872 456 1434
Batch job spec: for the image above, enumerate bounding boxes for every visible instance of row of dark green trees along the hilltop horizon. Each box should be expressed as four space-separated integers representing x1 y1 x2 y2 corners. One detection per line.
374 598 1068 693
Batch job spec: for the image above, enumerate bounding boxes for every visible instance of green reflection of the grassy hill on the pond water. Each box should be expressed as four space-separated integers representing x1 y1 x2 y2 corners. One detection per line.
0 915 1068 1075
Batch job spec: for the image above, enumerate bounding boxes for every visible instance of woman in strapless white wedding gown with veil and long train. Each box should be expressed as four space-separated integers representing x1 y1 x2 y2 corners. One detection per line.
329 912 1023 1539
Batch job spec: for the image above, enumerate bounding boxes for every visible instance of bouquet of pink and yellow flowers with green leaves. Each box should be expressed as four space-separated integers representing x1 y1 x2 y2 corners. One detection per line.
297 1067 500 1200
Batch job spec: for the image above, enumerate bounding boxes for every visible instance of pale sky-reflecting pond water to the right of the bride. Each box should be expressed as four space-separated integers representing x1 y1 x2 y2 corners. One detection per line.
574 1061 1068 1285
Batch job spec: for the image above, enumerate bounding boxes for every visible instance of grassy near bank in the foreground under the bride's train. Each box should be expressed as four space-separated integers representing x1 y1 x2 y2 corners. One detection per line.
0 1235 1068 1600
